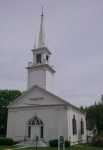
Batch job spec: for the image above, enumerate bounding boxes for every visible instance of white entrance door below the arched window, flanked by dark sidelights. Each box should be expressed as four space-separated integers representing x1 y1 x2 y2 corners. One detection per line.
31 126 40 140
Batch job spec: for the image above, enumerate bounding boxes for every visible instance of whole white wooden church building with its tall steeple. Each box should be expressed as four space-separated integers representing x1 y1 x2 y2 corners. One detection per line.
7 11 86 144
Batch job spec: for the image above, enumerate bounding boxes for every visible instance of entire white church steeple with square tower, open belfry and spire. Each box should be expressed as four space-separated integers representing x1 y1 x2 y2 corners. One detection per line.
26 7 55 92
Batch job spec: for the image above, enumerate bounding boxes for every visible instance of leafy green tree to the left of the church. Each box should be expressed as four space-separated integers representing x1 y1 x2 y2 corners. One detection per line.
0 90 22 136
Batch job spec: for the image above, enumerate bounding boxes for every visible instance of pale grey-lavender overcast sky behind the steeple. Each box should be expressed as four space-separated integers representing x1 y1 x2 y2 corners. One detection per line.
0 0 103 106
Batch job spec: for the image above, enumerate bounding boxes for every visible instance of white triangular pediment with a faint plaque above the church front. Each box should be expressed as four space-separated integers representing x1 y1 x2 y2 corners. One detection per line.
8 86 68 108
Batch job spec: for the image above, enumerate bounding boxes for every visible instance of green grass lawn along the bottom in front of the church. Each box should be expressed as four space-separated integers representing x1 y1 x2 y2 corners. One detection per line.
0 145 103 150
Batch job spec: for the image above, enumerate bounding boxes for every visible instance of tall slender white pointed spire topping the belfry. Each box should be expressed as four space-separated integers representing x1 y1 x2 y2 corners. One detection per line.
38 6 45 48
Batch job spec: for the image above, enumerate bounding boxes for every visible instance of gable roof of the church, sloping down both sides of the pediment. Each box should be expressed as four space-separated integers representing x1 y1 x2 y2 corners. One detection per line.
7 85 85 114
